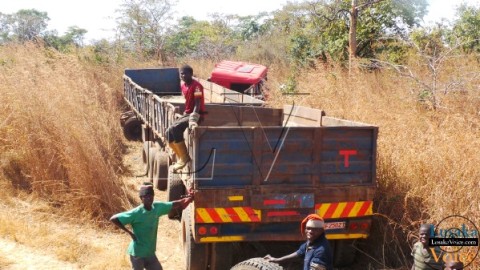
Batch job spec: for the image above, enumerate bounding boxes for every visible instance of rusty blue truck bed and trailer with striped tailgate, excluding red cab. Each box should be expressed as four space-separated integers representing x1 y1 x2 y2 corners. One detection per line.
123 68 378 270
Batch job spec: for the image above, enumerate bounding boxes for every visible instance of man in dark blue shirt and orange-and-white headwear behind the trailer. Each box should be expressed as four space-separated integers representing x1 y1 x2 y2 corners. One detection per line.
264 214 333 270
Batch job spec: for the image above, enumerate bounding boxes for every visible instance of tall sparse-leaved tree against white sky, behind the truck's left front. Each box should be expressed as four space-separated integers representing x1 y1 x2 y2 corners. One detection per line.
117 0 173 58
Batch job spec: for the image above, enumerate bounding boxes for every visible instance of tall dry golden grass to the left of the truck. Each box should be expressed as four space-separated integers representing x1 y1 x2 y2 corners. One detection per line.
0 44 128 220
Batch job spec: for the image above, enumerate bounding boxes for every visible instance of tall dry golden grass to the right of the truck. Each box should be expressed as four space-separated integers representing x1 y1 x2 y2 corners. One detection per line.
270 58 480 269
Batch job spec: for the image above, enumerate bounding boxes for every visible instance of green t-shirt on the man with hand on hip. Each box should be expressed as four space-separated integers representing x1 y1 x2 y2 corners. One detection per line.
116 202 172 257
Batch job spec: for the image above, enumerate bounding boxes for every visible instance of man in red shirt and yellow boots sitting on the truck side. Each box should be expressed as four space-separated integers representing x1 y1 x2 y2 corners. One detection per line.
167 65 205 172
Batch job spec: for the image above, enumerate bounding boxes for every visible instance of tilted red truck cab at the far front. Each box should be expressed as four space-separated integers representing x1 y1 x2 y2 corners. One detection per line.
209 60 267 100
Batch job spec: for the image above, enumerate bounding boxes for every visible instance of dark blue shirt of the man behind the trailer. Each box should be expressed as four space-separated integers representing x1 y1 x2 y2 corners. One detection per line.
297 233 333 270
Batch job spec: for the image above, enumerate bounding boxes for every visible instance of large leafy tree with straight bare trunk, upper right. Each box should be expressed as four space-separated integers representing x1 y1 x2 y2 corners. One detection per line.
275 0 427 67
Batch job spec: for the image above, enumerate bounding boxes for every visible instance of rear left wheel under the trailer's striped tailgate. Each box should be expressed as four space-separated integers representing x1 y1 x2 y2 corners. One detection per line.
182 206 208 270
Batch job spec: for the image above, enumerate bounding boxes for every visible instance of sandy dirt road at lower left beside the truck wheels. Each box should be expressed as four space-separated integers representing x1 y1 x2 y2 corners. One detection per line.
0 143 184 270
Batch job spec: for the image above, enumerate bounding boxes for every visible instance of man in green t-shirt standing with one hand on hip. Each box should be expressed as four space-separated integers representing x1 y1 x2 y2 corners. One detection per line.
110 183 193 270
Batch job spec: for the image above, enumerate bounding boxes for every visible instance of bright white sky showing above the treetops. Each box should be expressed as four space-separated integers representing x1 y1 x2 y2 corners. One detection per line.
0 0 480 41
